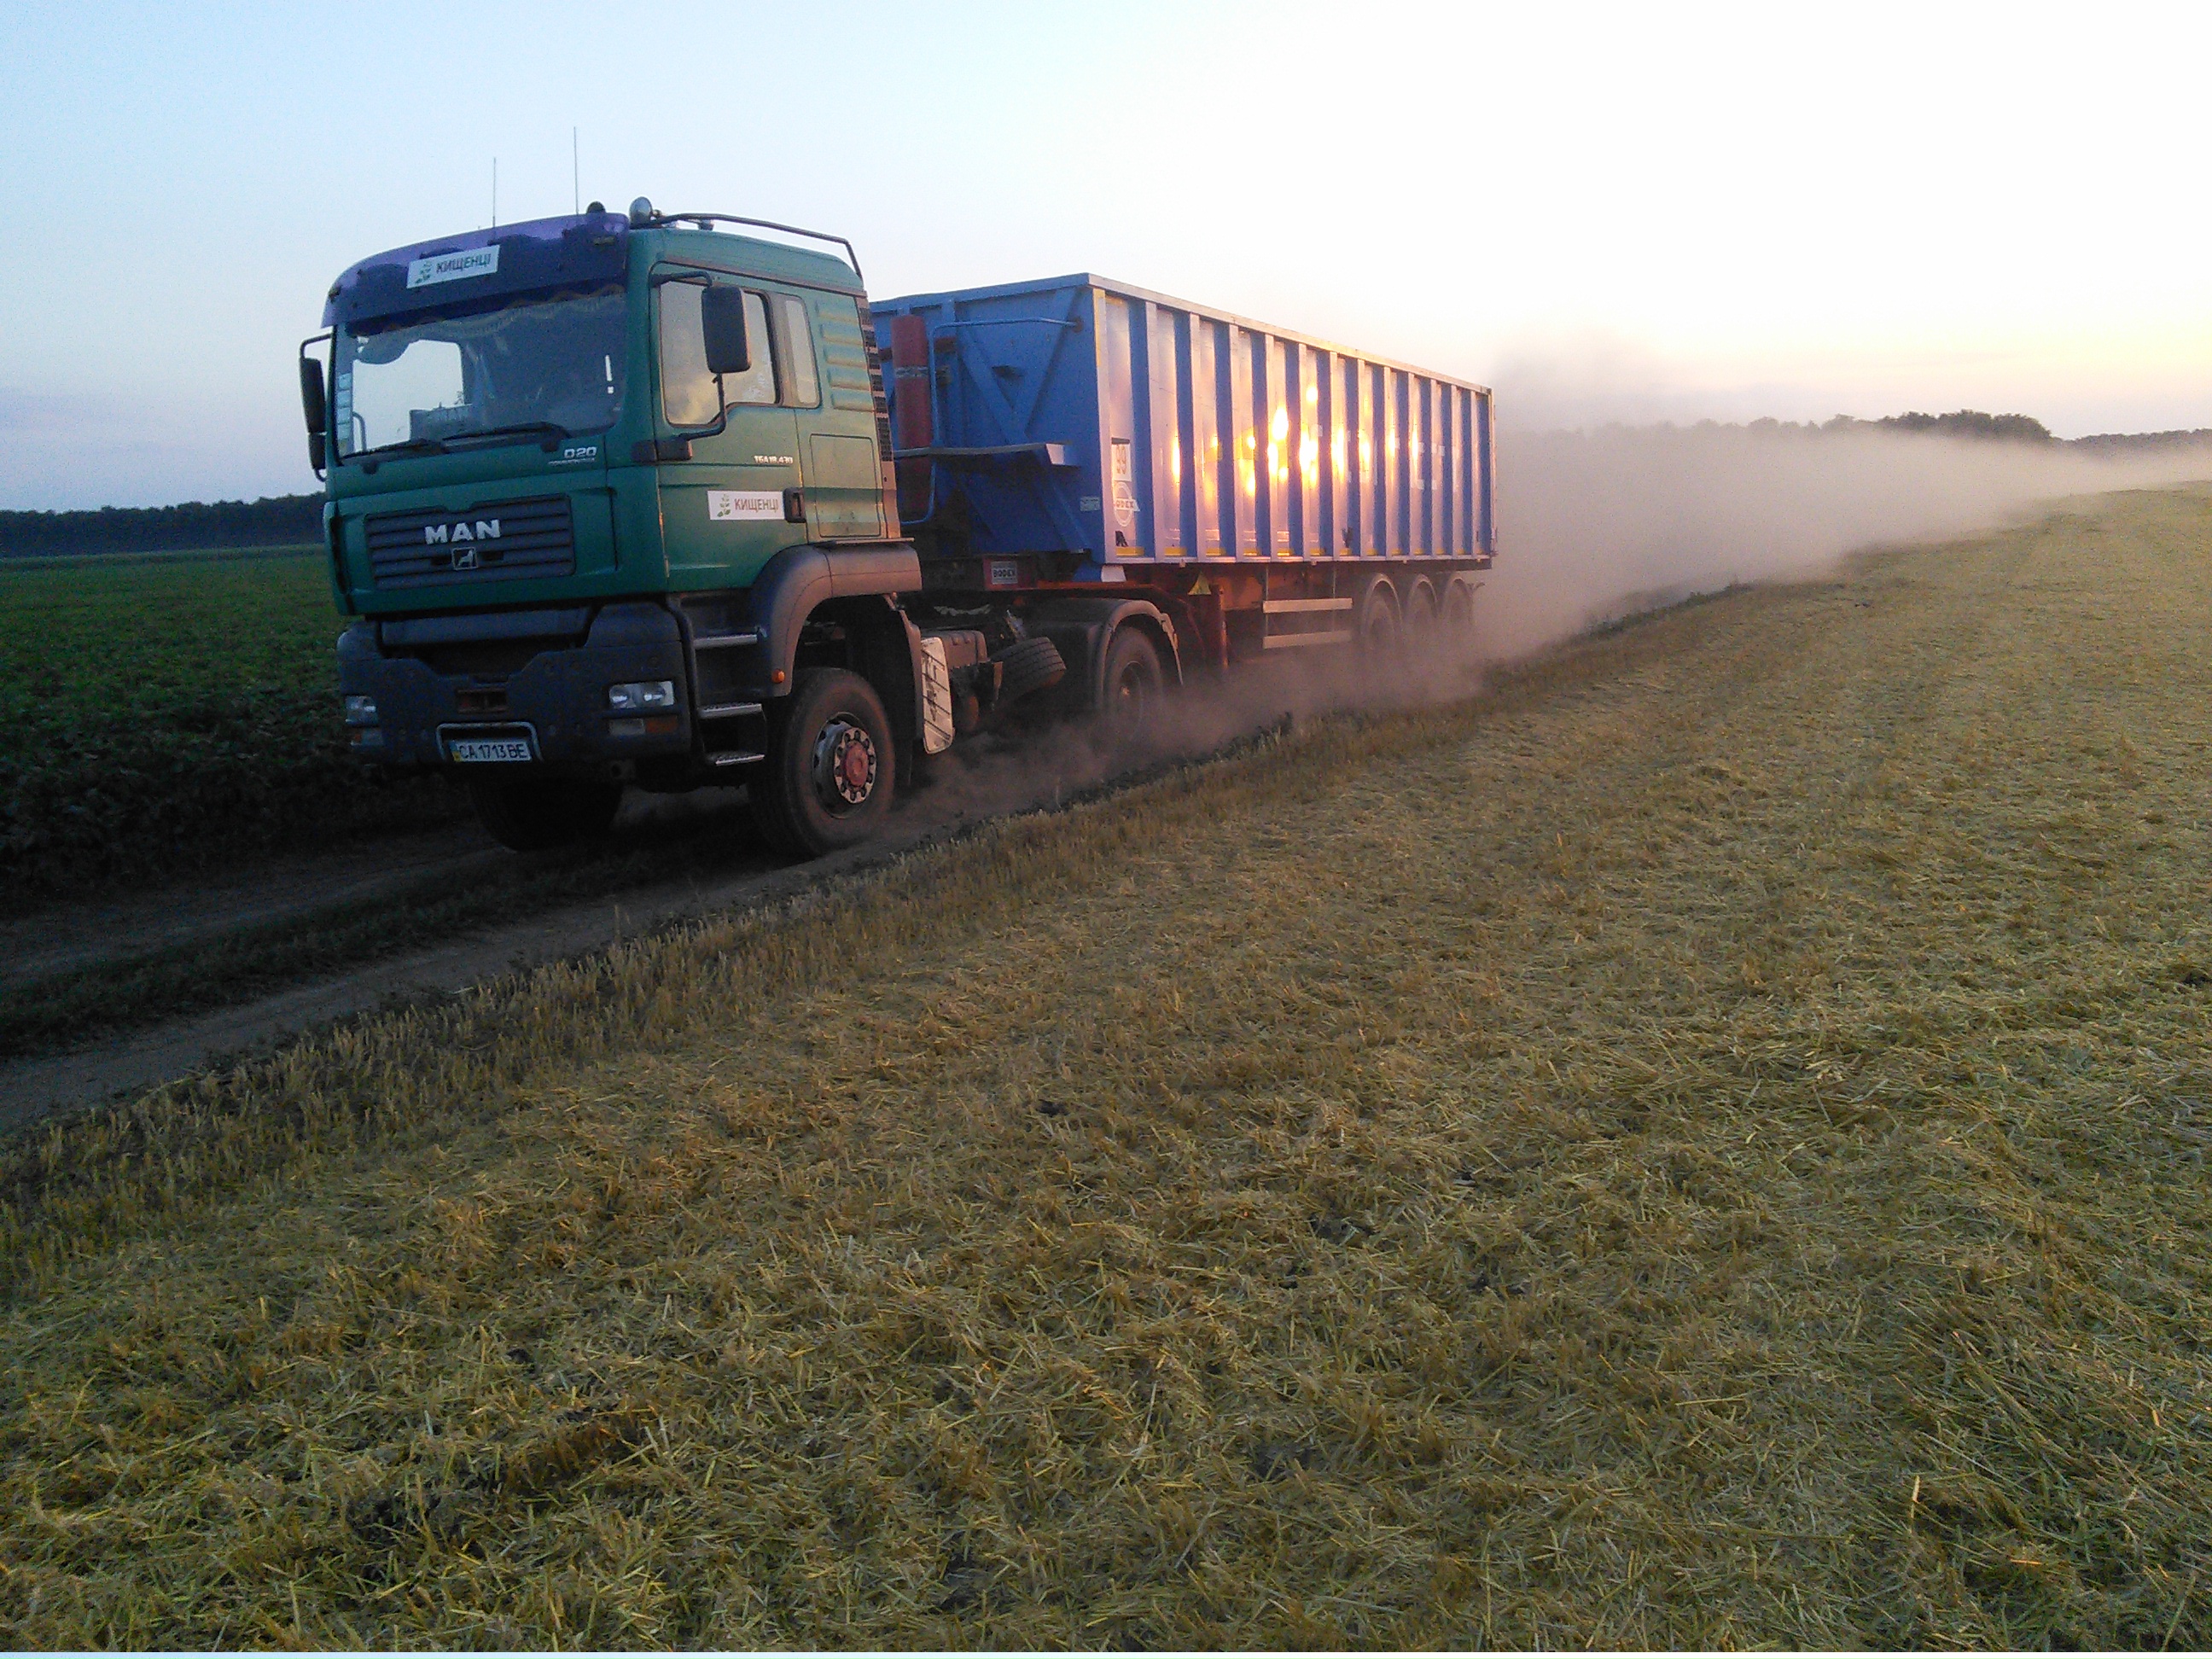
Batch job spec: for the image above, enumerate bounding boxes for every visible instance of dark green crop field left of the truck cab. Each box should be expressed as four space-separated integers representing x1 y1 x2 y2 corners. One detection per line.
0 549 453 907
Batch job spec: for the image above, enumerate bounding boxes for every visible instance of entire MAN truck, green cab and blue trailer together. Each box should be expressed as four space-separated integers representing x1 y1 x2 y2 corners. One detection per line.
299 199 1495 854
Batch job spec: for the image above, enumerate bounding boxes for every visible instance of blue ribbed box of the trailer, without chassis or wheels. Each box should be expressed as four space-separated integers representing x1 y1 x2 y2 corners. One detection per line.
874 274 1495 564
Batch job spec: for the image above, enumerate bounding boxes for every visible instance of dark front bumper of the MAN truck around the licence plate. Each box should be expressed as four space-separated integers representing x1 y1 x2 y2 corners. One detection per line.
339 602 695 777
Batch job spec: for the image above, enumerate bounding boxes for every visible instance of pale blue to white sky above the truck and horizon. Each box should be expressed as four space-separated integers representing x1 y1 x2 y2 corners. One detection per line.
0 0 2212 509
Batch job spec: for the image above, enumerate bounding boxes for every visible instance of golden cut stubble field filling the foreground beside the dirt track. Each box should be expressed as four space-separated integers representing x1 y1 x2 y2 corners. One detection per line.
0 493 2212 1648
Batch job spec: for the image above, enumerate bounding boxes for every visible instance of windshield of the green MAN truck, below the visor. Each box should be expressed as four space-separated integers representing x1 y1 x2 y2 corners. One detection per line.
334 285 624 456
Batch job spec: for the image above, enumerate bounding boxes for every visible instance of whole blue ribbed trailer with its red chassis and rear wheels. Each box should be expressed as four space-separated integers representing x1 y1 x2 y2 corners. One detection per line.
874 274 1495 706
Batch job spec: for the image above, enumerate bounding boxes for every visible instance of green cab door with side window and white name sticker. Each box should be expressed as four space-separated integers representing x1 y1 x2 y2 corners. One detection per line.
655 270 814 588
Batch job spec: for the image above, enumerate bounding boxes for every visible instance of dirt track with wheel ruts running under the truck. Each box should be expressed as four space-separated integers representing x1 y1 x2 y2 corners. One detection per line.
0 666 1380 1132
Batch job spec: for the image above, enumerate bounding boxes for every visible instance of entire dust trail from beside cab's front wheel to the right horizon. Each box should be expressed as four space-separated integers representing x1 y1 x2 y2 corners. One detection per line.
918 422 2212 823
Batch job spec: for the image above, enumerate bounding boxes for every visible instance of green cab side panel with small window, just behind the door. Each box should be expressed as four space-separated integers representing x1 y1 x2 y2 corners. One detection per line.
777 292 885 542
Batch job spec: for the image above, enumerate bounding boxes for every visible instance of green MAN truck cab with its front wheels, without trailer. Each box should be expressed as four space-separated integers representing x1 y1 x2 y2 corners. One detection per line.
301 203 951 852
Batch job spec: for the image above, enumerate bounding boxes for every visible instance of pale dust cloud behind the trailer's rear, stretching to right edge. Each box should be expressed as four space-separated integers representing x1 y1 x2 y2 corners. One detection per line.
1480 422 2212 657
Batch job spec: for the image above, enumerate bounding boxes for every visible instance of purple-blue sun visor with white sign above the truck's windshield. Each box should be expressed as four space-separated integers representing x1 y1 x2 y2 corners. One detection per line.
323 212 631 328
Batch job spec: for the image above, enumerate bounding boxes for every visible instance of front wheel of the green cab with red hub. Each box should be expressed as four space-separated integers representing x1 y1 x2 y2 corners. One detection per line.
748 668 896 859
